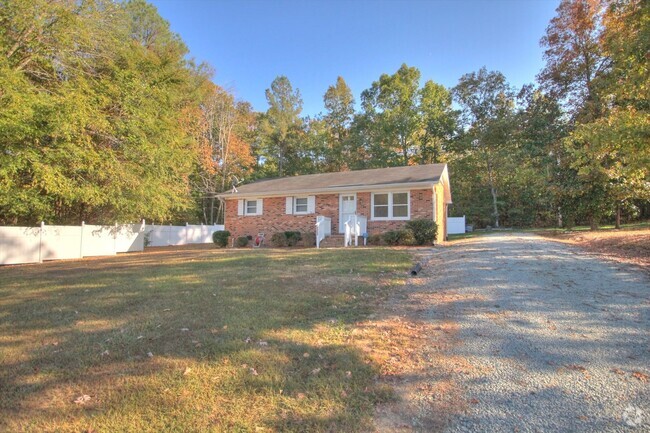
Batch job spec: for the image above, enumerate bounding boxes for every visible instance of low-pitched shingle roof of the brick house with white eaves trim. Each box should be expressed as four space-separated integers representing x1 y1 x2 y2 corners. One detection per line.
219 164 446 198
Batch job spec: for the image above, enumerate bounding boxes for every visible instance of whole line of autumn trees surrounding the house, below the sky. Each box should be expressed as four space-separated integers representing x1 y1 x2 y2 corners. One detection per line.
0 0 650 227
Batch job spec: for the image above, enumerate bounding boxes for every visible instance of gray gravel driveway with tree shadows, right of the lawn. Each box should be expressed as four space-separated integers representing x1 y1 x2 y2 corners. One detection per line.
426 233 650 432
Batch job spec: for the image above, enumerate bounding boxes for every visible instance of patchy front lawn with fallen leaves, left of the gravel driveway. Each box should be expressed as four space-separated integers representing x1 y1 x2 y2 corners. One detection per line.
0 249 410 432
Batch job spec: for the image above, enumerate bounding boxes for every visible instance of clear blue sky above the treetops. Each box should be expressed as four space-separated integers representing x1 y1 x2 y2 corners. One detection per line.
150 0 559 116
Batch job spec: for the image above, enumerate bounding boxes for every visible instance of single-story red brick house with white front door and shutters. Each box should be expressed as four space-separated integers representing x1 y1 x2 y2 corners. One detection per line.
219 164 451 244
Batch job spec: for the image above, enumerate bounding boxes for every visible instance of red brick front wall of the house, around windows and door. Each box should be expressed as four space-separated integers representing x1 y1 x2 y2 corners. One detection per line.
225 185 436 239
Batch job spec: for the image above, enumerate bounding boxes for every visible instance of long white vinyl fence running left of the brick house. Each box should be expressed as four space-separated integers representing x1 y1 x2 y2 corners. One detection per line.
0 221 224 265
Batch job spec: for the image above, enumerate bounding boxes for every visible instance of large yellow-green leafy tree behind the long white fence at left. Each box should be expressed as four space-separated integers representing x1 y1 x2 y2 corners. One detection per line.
0 0 207 224
